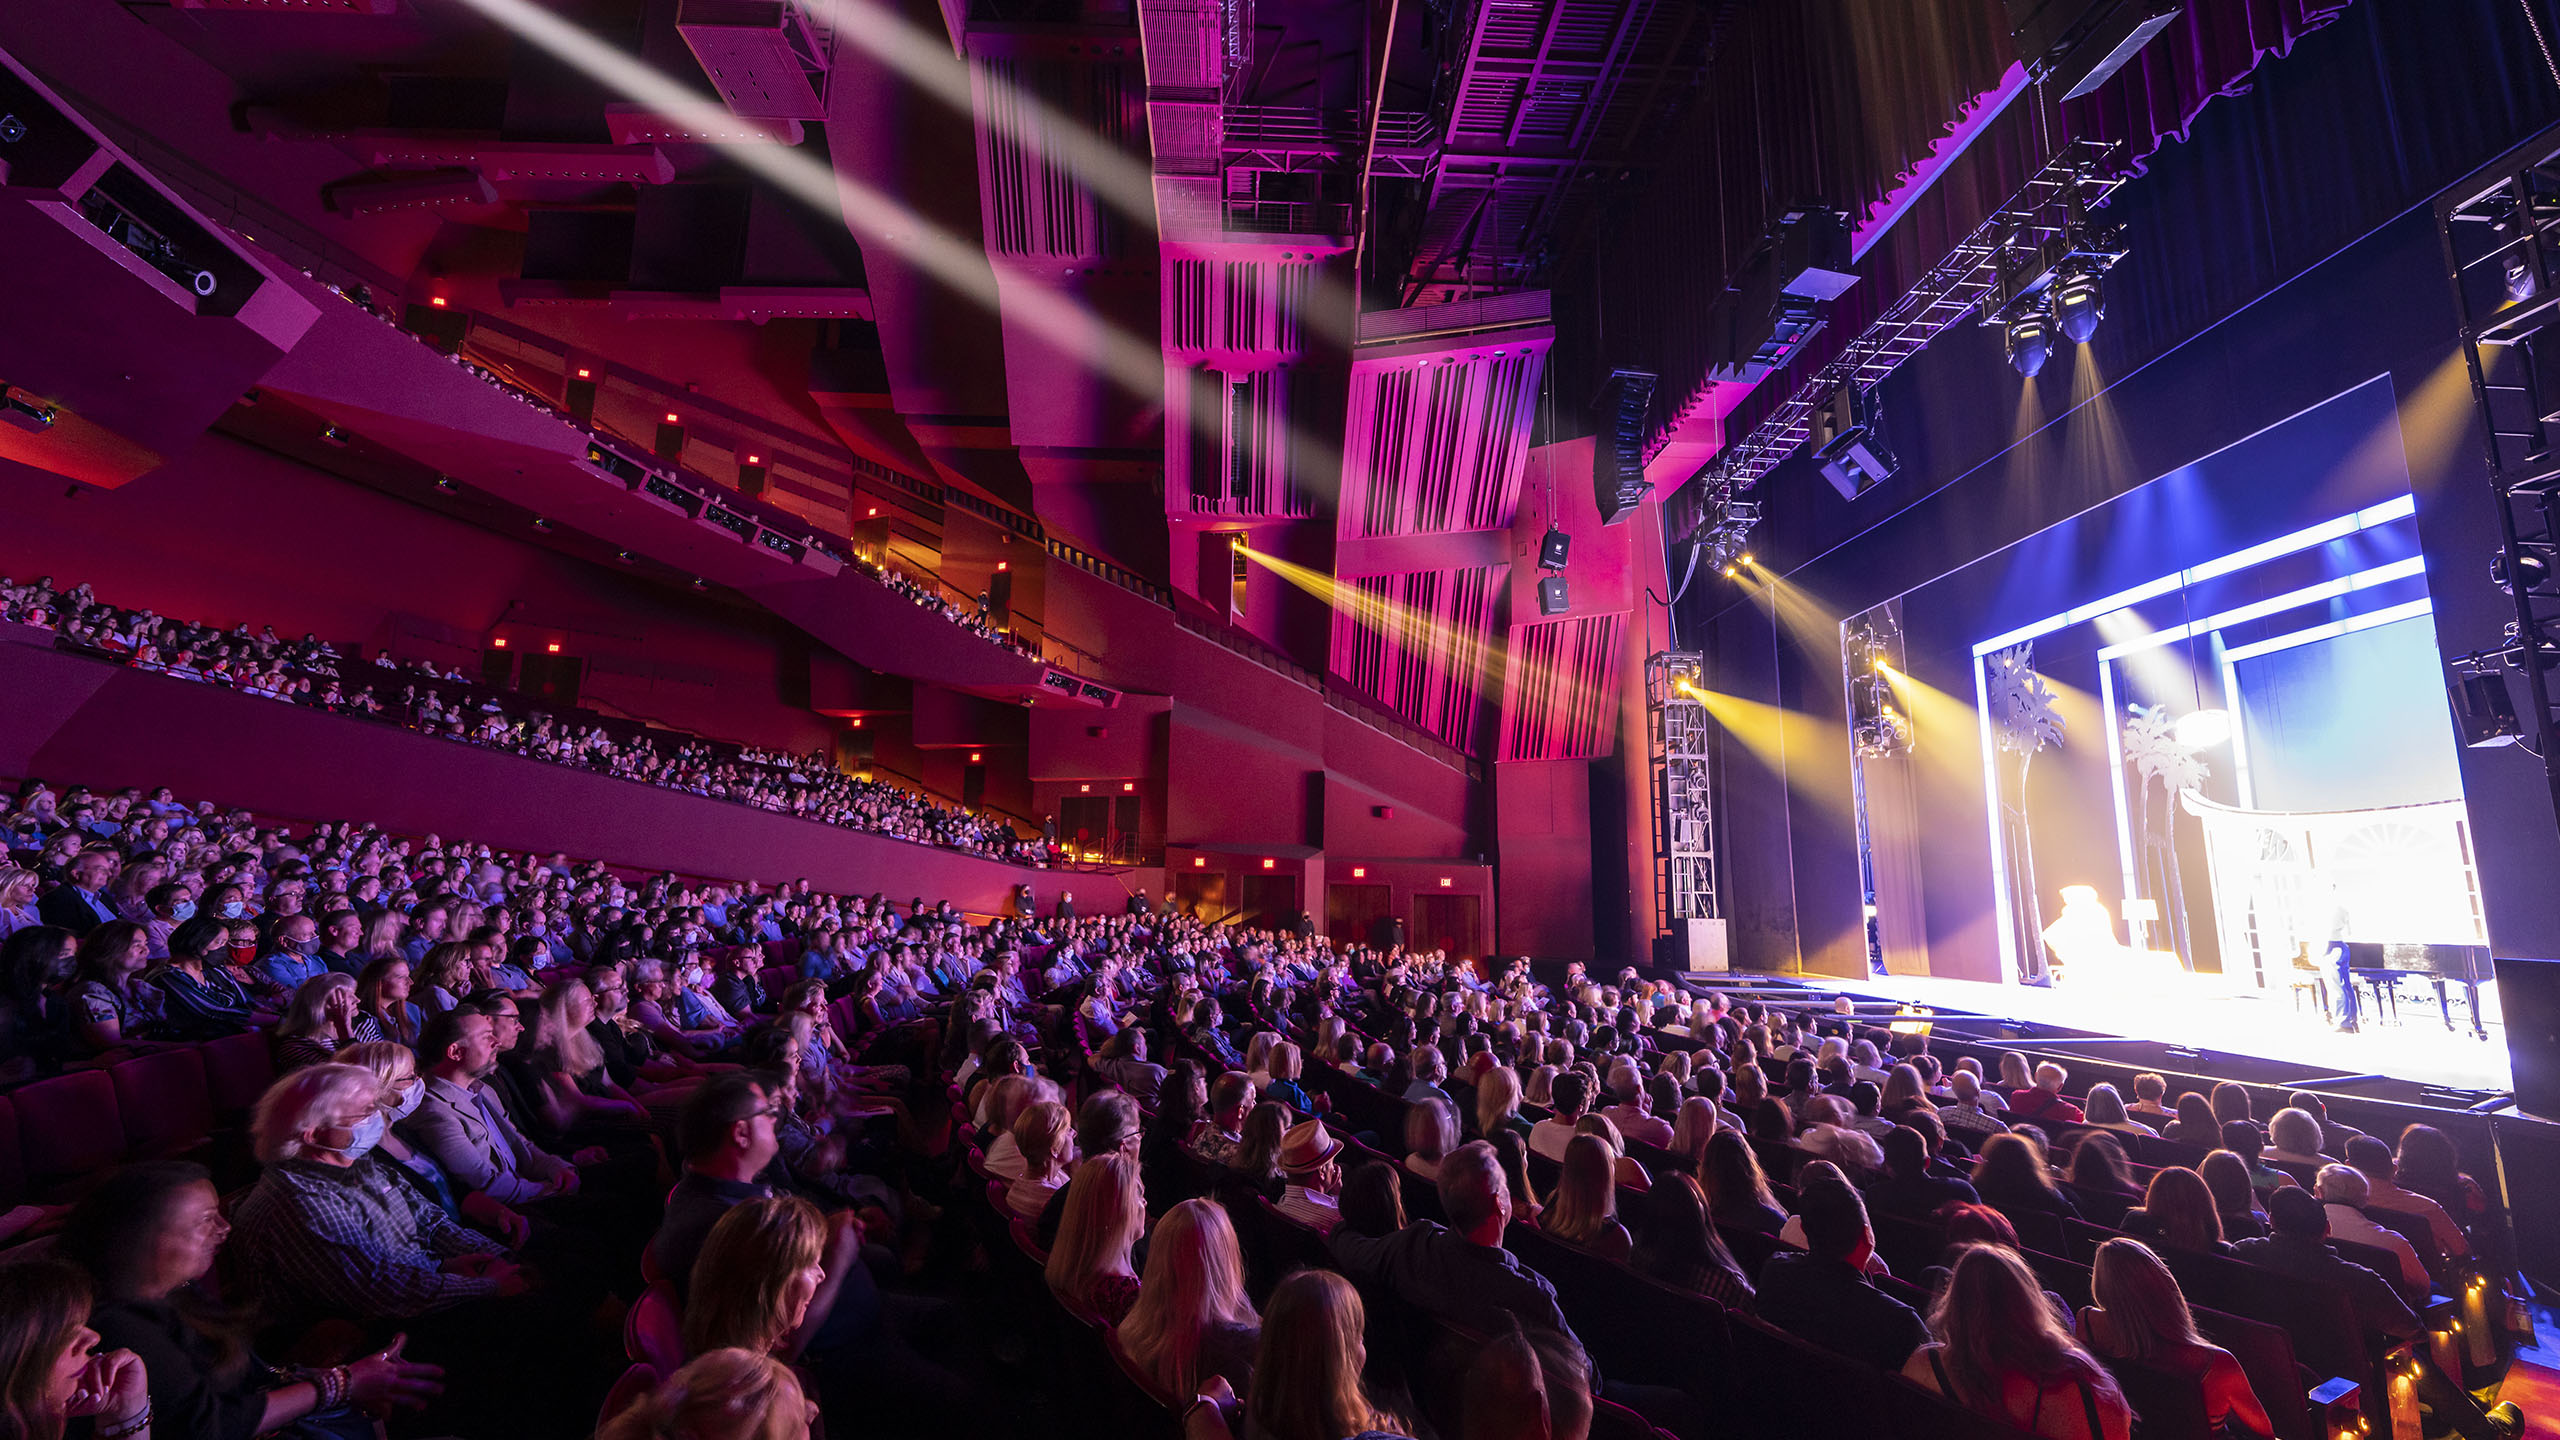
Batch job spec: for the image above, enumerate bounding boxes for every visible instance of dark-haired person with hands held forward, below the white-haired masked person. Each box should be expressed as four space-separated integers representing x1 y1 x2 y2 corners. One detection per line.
56 1161 443 1440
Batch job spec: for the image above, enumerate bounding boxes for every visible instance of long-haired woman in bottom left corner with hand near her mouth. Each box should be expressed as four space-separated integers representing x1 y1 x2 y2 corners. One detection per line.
0 1258 151 1440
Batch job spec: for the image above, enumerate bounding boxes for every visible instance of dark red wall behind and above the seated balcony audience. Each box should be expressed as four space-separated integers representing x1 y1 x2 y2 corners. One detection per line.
0 425 835 751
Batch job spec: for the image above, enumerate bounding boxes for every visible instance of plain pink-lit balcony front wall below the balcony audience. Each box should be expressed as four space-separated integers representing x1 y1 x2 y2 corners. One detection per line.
0 635 1105 912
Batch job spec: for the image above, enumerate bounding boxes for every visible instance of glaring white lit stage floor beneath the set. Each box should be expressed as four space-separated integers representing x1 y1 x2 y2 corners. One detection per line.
1730 974 2514 1092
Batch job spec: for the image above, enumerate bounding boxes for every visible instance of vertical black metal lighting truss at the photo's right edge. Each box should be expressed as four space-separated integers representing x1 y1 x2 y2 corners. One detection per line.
2435 126 2560 810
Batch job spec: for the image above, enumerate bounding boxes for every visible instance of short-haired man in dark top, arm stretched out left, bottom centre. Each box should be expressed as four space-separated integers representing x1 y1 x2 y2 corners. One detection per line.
1331 1140 1572 1335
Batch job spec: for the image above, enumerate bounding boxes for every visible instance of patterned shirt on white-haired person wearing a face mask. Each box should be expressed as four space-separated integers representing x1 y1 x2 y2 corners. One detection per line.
233 1156 504 1320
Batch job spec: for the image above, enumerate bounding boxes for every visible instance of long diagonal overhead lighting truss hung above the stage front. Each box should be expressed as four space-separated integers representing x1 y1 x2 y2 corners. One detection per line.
1672 141 2122 538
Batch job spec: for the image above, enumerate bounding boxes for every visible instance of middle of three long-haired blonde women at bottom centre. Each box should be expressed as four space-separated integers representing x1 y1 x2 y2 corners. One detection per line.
1116 1199 1262 1396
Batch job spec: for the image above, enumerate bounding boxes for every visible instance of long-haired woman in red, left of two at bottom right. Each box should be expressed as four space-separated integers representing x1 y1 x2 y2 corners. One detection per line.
1902 1245 2132 1440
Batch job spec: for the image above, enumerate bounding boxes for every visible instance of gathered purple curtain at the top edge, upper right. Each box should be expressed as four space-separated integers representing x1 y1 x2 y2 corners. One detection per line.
2063 0 2350 174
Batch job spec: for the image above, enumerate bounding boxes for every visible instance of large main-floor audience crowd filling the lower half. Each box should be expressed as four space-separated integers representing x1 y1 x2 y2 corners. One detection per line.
0 781 2506 1440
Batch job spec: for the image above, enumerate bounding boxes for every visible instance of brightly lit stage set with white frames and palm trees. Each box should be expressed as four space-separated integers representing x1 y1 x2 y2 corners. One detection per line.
1710 382 2511 1092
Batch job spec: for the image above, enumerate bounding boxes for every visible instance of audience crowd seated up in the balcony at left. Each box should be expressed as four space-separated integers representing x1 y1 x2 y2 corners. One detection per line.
0 577 1052 866
